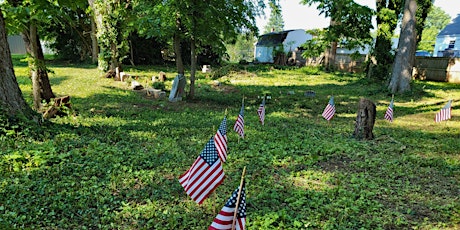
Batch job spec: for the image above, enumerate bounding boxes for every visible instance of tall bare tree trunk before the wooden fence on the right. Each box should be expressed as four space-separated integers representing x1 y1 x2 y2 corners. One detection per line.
388 0 417 93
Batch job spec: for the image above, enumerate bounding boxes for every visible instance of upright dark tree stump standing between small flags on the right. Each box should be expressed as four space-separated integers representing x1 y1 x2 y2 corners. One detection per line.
353 98 376 140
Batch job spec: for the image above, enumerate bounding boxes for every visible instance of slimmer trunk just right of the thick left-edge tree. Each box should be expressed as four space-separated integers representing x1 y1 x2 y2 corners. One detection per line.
22 21 55 110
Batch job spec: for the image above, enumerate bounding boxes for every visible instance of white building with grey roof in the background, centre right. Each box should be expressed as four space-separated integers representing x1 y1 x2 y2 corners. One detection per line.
254 29 313 63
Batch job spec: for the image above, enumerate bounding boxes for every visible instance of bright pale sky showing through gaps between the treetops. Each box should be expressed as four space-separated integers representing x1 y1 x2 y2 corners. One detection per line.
256 0 460 33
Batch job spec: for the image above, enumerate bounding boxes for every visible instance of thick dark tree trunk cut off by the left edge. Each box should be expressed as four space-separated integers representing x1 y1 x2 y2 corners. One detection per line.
0 9 33 118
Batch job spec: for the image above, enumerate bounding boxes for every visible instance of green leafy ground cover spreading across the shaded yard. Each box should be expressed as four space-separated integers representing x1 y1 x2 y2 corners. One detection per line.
0 55 460 229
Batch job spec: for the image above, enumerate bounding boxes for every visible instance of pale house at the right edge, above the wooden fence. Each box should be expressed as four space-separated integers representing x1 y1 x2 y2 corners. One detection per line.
433 14 460 57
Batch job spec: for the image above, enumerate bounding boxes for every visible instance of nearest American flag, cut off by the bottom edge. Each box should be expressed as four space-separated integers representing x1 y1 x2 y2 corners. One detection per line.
208 184 246 230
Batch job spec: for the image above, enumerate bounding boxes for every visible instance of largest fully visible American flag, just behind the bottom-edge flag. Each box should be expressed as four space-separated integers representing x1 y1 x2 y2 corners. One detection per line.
179 137 225 204
